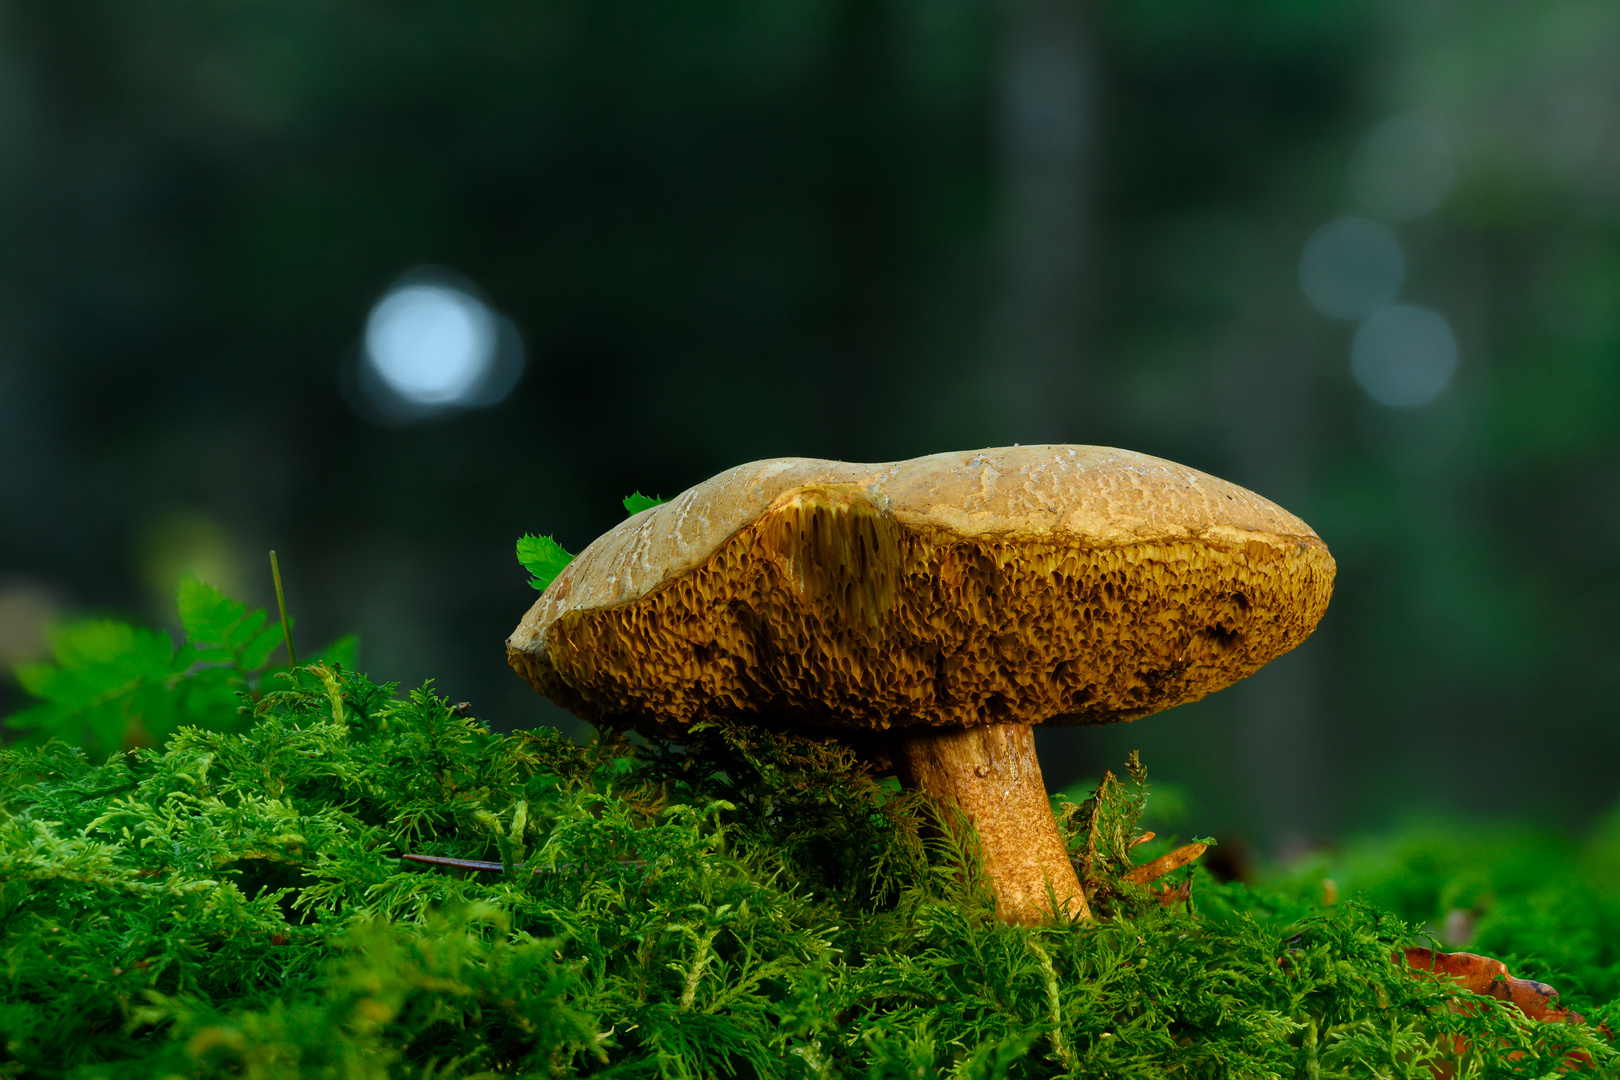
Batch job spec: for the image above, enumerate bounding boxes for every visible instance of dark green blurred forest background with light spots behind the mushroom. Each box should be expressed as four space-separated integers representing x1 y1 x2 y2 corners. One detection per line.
0 0 1620 855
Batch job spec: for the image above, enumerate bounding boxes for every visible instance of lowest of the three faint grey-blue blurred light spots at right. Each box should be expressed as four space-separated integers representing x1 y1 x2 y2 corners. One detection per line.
1349 304 1456 408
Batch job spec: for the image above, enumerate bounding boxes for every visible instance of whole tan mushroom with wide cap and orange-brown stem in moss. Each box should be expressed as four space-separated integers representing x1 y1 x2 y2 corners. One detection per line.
507 445 1333 925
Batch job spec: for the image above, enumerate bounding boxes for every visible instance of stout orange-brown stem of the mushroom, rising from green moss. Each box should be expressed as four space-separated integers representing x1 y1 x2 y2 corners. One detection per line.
891 724 1090 926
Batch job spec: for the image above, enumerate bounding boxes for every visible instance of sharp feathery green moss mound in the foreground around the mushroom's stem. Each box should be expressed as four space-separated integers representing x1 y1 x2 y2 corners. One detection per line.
0 595 1615 1078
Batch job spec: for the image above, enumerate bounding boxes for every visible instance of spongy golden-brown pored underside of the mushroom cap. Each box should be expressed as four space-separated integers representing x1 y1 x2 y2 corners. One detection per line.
509 486 1333 733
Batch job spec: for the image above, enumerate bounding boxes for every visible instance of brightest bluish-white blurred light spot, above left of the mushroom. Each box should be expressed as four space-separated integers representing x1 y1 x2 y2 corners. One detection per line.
366 285 496 405
